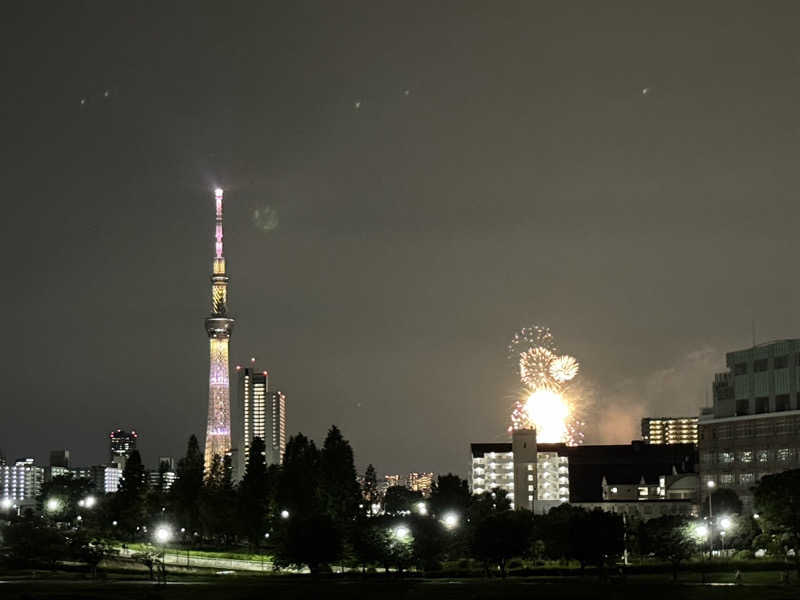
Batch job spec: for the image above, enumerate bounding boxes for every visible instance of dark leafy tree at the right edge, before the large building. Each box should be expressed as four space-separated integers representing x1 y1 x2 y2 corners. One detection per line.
754 469 800 575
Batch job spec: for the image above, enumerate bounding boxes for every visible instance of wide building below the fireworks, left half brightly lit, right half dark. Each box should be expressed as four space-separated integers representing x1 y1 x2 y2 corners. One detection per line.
470 430 697 515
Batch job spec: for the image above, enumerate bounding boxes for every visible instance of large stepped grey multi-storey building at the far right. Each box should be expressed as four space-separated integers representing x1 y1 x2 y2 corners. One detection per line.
698 339 800 509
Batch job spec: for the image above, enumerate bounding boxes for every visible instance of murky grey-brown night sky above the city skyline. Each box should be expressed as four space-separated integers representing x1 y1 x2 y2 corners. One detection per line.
0 1 800 474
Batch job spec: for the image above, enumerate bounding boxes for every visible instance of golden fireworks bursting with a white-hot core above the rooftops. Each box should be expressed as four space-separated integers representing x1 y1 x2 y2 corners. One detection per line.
508 325 583 445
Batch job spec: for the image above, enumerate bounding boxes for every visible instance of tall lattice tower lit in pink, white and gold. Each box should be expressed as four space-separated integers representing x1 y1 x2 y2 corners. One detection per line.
205 188 233 470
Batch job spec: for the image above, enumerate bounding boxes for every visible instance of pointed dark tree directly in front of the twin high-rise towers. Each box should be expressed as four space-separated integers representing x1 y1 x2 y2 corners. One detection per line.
239 437 269 548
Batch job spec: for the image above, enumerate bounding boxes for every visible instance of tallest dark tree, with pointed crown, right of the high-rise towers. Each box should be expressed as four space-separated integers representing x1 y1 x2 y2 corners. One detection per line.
319 425 362 526
